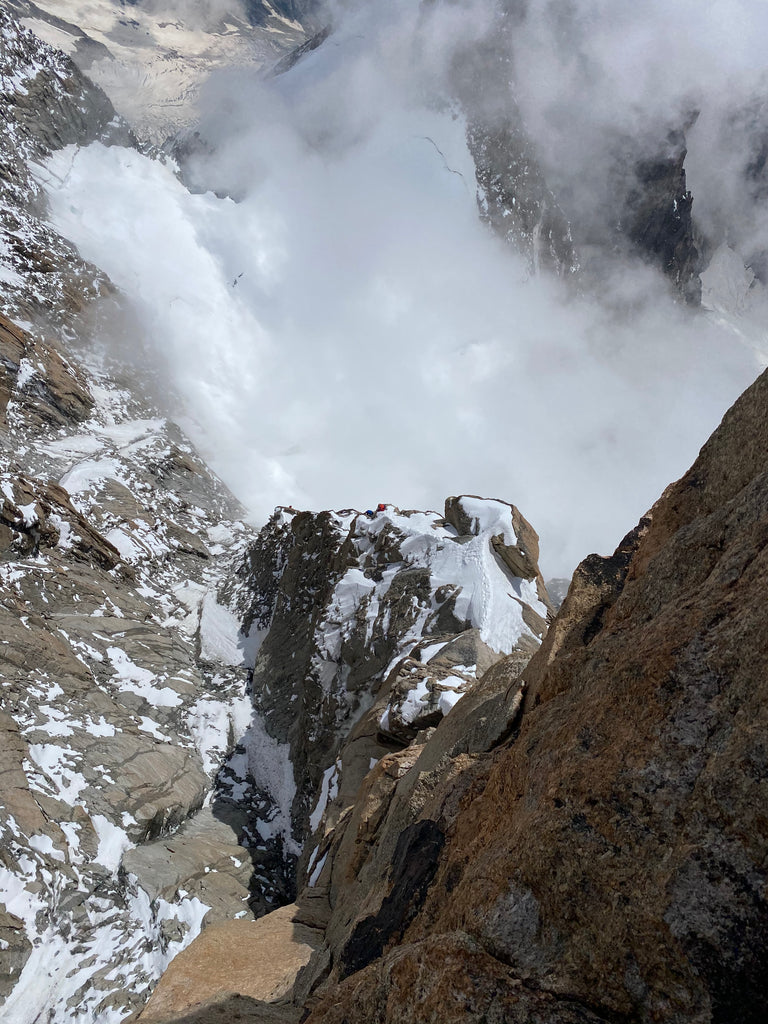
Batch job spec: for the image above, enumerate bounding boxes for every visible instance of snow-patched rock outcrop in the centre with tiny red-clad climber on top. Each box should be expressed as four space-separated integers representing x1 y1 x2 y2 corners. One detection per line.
225 496 550 888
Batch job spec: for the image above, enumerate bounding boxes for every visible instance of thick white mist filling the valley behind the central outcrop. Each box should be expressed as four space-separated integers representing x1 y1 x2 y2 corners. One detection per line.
43 0 766 575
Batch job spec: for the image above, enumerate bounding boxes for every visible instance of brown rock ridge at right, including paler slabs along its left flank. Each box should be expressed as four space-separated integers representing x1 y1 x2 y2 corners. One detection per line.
137 309 768 1024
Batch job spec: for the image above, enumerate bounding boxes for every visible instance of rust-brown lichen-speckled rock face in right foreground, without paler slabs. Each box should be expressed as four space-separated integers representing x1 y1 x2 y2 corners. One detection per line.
309 375 768 1024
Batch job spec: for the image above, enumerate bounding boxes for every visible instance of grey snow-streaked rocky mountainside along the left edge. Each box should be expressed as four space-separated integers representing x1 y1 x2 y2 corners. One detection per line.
0 12 282 1021
